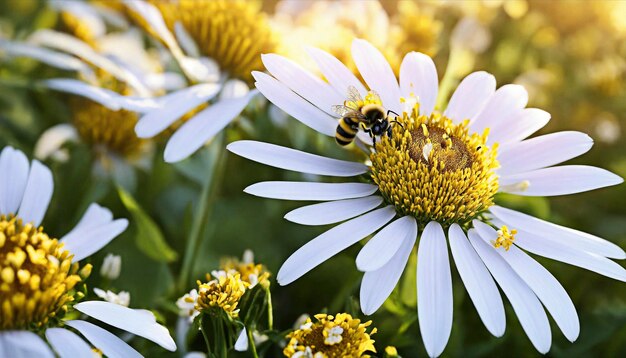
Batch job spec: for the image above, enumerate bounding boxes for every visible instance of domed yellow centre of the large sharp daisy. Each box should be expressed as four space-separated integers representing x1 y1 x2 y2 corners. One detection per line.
370 105 499 226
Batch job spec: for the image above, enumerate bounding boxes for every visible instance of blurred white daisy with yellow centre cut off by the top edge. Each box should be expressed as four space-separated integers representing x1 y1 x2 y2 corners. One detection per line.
125 1 260 163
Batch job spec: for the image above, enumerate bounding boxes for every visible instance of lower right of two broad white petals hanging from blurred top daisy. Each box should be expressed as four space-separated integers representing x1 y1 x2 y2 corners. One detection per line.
164 91 258 163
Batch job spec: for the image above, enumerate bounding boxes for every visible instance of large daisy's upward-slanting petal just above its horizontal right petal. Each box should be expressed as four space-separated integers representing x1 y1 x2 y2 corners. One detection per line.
498 131 593 175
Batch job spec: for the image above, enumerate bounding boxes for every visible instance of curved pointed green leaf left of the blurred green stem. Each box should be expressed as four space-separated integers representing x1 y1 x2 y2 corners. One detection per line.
117 187 178 262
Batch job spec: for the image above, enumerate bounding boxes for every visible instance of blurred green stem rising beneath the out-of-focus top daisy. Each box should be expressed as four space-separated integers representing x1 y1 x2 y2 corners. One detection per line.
178 136 226 292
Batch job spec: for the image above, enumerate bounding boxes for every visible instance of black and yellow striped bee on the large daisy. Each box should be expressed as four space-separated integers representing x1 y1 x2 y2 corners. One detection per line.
332 86 400 146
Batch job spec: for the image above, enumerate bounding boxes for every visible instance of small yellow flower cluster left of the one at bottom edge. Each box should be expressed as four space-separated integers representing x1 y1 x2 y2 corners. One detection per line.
196 273 250 318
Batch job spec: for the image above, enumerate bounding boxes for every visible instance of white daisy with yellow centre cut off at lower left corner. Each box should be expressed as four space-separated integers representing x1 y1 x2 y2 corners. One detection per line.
0 147 176 357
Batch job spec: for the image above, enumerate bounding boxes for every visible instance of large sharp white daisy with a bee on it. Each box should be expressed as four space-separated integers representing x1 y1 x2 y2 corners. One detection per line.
228 40 626 356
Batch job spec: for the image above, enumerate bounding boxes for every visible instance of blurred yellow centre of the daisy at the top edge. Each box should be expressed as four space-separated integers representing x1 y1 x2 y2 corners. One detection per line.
153 0 276 82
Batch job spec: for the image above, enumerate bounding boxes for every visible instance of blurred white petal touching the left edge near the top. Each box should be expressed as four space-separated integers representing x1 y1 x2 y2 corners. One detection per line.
0 40 93 76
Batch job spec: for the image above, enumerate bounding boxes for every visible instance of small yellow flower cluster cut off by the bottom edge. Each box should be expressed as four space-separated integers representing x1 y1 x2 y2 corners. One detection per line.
283 313 376 358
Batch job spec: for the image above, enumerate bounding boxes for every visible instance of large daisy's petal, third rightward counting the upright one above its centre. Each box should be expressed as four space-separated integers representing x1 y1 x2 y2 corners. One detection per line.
470 85 528 133
